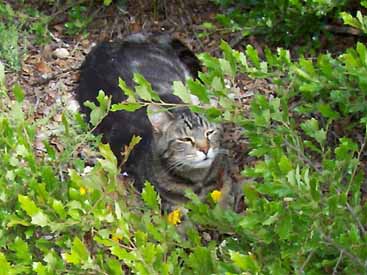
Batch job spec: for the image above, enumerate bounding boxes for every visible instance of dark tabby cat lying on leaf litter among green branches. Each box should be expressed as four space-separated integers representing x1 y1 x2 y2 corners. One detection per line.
77 34 236 208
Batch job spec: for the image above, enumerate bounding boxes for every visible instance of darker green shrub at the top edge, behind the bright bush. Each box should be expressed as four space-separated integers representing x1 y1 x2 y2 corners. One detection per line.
208 0 347 47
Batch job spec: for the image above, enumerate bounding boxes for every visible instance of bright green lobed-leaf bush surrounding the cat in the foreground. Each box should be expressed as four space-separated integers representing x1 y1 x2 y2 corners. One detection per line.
0 1 367 275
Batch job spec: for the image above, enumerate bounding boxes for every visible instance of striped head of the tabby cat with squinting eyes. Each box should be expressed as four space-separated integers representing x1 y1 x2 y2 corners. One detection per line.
149 106 222 171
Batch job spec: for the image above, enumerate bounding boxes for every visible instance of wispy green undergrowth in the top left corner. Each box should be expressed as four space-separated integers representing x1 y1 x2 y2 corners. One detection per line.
0 1 111 71
